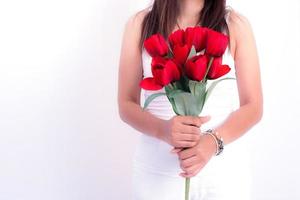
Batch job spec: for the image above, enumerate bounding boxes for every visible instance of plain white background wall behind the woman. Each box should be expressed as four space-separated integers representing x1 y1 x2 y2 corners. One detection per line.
0 0 300 200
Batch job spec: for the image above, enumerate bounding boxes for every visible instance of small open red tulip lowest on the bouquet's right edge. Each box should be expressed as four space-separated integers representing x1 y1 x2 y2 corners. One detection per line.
207 57 230 79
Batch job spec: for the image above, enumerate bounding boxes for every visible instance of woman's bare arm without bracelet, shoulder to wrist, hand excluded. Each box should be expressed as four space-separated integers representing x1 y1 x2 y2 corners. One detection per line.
118 13 163 138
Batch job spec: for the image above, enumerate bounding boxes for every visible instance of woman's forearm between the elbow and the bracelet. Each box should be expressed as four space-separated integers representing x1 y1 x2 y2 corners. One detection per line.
215 103 263 145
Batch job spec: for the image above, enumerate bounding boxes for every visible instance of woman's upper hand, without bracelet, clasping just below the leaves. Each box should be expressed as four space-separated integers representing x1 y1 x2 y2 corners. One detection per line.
161 116 210 148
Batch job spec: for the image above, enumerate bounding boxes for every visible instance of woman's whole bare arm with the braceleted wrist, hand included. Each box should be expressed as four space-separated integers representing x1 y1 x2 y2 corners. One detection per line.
178 11 263 177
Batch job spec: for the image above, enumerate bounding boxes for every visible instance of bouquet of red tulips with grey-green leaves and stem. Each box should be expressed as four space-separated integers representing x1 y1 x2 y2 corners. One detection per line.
140 26 235 200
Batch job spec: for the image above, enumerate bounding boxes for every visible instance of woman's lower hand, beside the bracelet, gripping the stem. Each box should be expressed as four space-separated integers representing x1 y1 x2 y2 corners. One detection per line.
177 135 216 177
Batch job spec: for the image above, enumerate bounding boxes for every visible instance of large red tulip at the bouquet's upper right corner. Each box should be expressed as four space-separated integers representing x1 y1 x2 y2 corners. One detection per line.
205 29 228 57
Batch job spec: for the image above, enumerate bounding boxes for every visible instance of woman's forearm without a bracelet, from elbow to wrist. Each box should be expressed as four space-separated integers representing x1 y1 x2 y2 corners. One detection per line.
119 101 165 139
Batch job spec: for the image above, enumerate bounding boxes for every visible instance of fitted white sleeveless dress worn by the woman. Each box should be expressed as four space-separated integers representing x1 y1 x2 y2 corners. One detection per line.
132 16 251 200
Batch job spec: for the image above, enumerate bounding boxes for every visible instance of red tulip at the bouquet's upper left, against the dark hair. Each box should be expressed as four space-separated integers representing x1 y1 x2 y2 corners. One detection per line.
144 34 169 57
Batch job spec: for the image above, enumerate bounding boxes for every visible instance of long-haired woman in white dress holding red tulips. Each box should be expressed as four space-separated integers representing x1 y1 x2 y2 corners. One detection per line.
118 0 263 200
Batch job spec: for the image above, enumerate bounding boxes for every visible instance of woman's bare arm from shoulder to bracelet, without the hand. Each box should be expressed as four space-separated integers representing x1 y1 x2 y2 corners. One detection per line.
212 11 263 144
